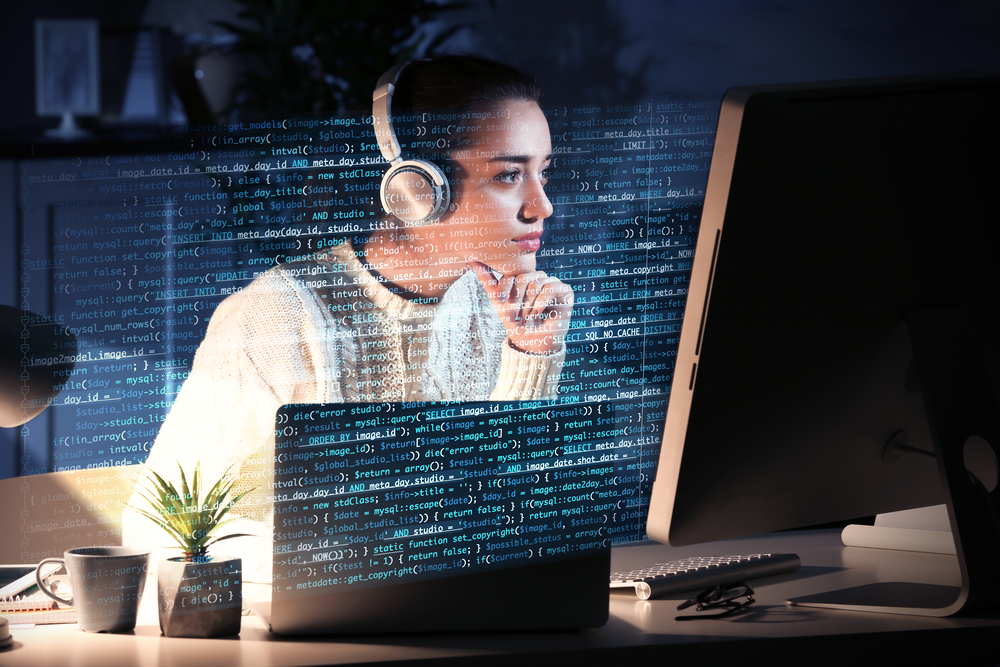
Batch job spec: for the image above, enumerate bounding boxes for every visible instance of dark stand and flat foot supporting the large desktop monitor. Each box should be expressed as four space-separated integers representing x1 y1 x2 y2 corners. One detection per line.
788 308 1000 617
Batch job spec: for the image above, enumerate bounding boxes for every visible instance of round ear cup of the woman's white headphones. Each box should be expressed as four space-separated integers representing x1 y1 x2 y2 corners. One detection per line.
380 160 451 226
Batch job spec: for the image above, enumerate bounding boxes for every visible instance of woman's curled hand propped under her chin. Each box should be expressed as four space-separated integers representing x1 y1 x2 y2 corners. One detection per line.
469 262 573 354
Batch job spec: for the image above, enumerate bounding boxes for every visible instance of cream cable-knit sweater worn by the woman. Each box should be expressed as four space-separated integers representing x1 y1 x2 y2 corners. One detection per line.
122 243 565 583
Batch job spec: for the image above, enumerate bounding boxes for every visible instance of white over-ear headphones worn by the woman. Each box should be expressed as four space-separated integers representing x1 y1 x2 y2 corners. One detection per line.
372 63 451 226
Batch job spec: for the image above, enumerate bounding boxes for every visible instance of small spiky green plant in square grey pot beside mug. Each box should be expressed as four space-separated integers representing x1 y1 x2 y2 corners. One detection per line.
132 462 252 637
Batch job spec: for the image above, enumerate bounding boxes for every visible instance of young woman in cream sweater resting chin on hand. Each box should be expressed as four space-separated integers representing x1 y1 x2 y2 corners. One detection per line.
124 56 573 581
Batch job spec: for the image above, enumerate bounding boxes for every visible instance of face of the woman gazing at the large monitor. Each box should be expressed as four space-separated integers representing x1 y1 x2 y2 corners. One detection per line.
438 101 552 275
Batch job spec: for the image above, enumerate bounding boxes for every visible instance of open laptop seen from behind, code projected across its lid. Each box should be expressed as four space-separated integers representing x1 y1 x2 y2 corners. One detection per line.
254 401 622 635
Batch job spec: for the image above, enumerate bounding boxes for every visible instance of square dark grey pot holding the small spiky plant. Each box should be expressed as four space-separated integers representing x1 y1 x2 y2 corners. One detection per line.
156 558 243 637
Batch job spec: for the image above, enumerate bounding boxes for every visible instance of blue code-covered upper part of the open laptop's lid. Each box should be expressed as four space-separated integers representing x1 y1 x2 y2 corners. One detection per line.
274 401 616 599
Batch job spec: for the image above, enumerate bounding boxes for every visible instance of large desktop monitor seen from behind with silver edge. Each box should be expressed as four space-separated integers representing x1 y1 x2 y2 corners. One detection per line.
647 70 1000 615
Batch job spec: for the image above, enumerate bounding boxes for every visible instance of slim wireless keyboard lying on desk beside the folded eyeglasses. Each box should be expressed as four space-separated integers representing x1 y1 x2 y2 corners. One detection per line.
611 554 802 600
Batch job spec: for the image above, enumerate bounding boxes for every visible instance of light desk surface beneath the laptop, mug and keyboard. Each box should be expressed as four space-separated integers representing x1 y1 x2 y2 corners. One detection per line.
0 531 1000 667
